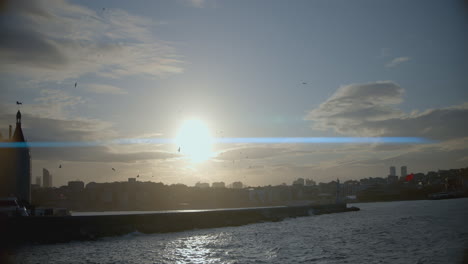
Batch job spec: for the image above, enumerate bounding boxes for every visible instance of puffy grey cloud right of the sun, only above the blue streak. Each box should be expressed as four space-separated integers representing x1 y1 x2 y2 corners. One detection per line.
306 81 468 140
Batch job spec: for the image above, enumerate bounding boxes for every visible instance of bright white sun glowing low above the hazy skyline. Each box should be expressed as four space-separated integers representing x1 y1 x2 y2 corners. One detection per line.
176 119 213 162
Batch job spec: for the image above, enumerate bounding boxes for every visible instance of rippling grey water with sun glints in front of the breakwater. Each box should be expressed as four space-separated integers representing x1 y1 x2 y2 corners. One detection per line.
11 199 468 263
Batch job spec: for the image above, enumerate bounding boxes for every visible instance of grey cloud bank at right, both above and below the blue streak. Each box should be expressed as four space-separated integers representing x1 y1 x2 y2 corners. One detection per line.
306 81 468 178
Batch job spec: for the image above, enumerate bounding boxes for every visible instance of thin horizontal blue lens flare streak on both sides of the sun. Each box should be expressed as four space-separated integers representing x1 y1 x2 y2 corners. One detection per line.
0 137 437 148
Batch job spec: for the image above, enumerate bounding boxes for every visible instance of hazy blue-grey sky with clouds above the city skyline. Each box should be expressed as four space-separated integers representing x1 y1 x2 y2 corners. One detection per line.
0 0 468 186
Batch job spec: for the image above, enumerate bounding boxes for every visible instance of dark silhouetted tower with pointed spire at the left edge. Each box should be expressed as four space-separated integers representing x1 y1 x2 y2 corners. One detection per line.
0 110 31 203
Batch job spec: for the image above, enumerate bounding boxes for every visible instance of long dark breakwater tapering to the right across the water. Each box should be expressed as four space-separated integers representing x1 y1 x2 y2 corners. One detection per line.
0 204 359 246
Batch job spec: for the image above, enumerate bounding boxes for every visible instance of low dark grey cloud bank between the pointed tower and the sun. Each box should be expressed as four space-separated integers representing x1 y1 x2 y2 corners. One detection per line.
0 114 177 162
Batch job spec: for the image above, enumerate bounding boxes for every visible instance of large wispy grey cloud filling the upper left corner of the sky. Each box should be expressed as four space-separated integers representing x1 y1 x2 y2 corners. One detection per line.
0 0 183 81
